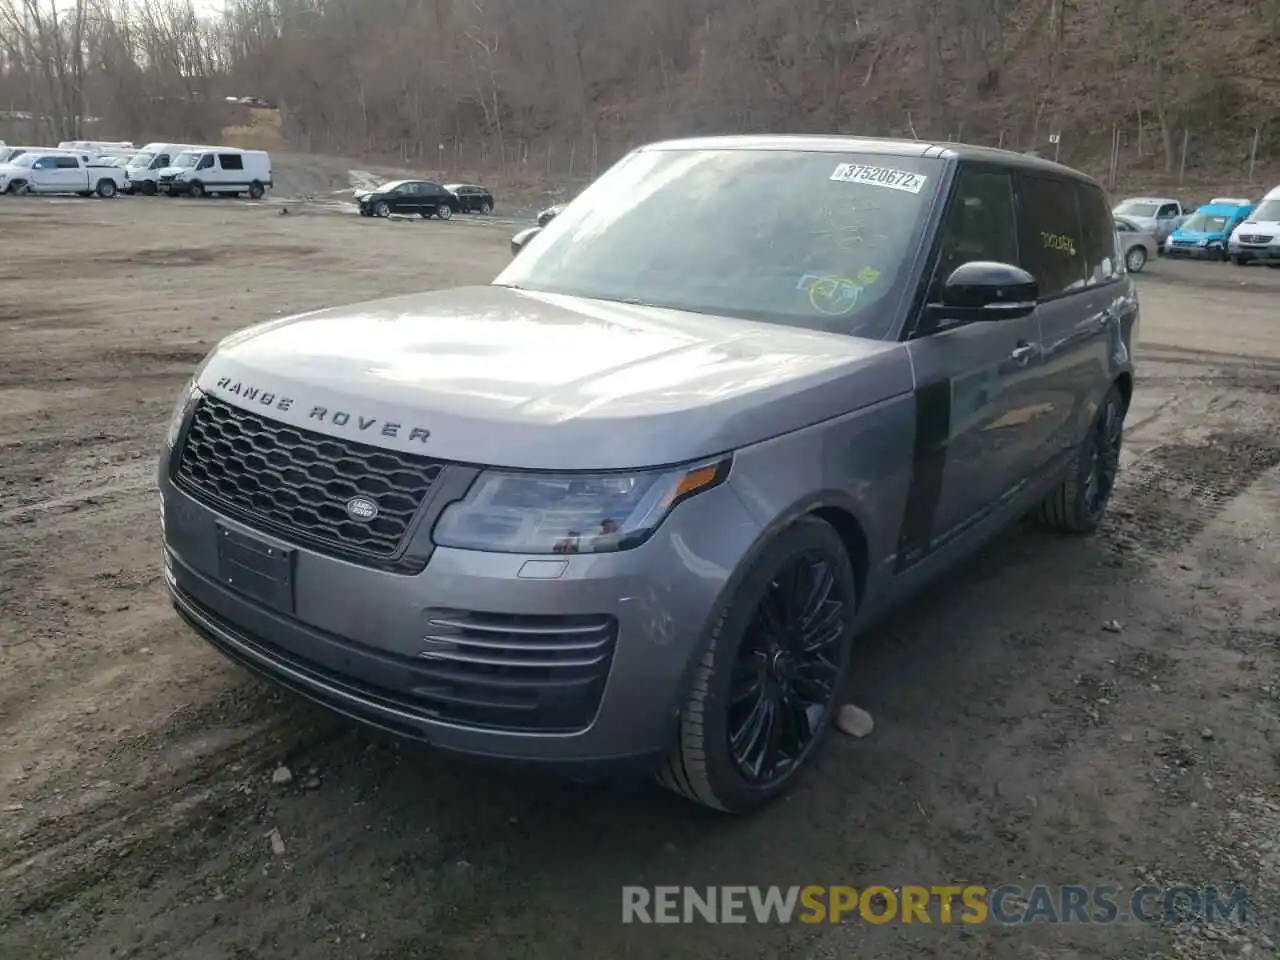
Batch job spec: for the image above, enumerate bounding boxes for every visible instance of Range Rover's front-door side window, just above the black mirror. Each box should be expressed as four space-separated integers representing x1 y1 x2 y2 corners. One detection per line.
929 166 1018 302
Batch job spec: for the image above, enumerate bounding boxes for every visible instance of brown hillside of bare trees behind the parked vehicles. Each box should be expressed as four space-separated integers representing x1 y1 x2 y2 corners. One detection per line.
0 0 1280 184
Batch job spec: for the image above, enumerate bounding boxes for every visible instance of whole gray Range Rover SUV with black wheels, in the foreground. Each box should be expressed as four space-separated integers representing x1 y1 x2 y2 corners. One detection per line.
159 137 1138 812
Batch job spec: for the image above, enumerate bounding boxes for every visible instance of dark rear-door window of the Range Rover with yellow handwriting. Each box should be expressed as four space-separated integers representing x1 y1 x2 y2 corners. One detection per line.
1021 174 1085 298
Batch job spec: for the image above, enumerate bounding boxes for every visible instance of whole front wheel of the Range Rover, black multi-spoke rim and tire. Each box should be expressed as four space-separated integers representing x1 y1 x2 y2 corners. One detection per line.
657 516 858 813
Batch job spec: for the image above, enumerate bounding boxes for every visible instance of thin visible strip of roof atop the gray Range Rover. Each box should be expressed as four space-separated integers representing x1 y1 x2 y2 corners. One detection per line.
641 133 1100 186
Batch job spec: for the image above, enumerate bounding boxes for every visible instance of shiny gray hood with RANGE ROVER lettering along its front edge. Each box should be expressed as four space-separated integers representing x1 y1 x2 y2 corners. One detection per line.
198 285 911 470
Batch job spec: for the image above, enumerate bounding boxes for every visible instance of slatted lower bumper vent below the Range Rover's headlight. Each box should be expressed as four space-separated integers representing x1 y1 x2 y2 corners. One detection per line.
411 609 617 732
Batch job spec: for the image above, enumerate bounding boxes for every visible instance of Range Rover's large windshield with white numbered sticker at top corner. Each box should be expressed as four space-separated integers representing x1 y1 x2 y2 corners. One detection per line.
494 148 942 338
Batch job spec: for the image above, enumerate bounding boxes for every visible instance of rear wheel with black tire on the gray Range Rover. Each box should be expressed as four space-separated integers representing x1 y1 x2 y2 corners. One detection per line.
1037 384 1128 534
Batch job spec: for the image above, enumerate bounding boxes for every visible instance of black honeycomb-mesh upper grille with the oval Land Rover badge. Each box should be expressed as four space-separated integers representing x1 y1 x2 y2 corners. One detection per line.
174 397 444 572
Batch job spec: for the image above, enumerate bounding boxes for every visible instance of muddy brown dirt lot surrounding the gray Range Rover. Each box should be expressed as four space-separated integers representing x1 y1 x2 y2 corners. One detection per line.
0 198 1280 960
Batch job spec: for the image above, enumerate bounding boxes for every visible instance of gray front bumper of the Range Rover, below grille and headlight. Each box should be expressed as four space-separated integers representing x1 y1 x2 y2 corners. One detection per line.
159 465 760 768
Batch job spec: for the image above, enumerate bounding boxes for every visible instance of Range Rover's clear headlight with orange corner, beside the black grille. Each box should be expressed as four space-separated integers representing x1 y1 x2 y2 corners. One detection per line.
433 457 732 553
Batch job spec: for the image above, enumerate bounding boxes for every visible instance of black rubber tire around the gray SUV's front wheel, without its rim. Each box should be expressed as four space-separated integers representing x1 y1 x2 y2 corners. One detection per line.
657 517 858 813
